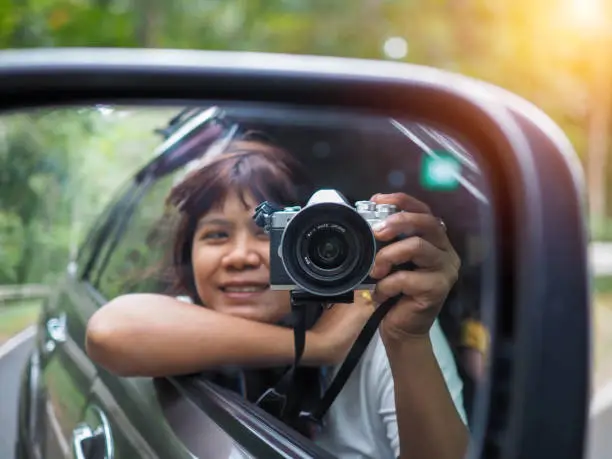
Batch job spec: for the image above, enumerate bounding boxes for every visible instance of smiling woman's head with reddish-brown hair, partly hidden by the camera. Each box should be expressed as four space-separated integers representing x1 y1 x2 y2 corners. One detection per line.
161 137 308 323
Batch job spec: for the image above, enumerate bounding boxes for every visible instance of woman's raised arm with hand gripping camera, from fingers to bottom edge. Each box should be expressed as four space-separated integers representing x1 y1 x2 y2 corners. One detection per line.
371 193 469 459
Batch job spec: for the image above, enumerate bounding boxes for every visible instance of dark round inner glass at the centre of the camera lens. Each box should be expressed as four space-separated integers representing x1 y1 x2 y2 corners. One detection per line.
306 227 348 269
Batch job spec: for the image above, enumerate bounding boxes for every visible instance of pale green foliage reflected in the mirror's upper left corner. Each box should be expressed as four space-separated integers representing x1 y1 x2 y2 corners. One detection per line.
0 107 177 284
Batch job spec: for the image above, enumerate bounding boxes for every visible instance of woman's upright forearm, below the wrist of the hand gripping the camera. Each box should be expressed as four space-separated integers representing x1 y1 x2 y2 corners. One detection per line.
385 337 469 459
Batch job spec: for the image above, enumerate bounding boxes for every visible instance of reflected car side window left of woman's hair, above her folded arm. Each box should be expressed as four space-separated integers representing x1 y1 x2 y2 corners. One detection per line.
90 108 231 299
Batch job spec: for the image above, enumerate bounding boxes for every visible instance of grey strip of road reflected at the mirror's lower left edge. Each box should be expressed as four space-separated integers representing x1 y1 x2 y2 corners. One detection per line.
0 334 34 459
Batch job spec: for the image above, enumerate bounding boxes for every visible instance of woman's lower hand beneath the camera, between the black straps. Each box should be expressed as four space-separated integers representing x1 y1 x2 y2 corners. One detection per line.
307 292 374 365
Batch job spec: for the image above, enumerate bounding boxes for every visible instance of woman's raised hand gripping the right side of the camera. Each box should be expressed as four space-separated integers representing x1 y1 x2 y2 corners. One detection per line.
371 193 461 343
